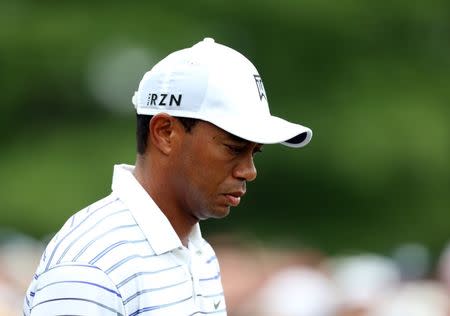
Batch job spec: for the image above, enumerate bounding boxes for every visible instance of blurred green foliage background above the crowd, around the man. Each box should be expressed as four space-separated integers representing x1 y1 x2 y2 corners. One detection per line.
0 0 450 262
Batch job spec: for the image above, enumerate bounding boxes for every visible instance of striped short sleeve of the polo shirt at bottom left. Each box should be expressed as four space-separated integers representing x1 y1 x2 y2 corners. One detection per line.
24 263 126 316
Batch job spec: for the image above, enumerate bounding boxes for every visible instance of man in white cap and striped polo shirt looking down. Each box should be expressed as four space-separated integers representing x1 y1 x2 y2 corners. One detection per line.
24 38 312 316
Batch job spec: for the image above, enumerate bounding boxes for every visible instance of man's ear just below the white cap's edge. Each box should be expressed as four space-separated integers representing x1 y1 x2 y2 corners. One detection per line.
149 113 179 155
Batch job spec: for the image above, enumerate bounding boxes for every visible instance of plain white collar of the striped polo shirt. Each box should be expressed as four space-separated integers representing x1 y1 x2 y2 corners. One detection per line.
112 164 202 255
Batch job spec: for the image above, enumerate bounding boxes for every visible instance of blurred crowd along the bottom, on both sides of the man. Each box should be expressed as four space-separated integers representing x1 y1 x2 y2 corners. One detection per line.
0 233 450 316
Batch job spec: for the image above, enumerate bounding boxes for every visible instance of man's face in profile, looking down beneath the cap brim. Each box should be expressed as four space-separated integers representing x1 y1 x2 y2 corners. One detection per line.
172 121 262 220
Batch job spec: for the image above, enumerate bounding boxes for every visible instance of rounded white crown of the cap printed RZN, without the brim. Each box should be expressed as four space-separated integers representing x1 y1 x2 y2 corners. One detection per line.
133 38 270 121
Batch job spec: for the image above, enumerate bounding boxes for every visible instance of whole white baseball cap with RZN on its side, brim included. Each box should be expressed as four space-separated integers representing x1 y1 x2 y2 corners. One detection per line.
133 38 312 147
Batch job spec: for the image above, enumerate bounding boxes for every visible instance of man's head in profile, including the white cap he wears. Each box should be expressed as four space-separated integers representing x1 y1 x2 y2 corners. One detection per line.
133 39 312 220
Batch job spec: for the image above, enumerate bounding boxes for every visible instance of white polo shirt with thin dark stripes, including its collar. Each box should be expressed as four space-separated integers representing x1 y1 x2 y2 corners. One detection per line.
24 165 226 316
